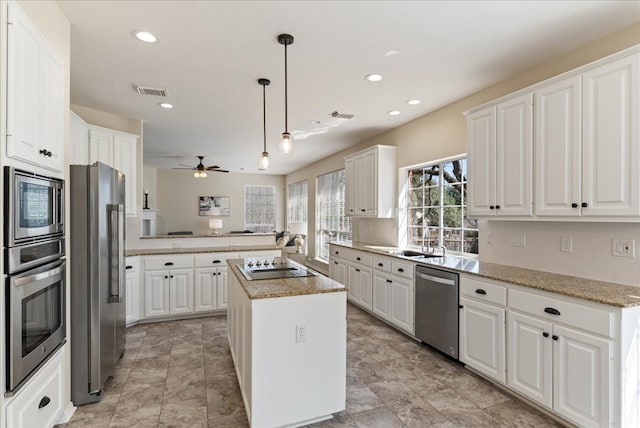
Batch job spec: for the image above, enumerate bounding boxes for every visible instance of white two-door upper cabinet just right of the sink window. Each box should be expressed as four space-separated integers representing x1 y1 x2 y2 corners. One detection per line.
467 93 533 216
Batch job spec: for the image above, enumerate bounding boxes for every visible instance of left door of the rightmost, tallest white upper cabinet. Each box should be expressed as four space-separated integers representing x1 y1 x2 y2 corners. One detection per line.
535 76 582 216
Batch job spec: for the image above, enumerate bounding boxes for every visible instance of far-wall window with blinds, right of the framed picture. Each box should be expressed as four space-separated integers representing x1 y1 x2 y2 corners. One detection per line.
244 184 276 232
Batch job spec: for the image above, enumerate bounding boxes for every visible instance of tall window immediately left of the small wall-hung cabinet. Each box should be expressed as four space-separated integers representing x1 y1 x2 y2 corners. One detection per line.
316 169 351 261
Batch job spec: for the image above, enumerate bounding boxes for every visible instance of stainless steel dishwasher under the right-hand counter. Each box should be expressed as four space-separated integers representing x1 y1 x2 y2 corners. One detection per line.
415 266 459 360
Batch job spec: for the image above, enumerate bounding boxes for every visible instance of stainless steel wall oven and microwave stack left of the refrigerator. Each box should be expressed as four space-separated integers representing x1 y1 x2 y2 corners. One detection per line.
4 167 66 394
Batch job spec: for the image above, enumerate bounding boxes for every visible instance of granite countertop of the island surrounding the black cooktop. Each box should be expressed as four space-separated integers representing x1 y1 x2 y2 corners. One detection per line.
227 259 347 300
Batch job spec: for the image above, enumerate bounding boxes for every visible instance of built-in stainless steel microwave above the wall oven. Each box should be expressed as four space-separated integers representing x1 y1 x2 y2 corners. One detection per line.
6 167 64 247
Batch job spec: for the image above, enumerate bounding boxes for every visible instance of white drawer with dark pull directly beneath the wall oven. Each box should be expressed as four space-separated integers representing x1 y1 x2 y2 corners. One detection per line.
7 351 63 428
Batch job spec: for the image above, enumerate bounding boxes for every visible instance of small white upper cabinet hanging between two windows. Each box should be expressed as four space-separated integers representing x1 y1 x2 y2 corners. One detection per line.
344 146 398 218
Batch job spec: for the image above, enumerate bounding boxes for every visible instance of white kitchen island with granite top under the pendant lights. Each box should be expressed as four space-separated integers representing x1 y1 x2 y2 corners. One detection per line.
227 259 347 428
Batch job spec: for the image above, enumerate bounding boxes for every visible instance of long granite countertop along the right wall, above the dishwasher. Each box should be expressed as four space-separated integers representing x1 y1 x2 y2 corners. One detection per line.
332 242 640 308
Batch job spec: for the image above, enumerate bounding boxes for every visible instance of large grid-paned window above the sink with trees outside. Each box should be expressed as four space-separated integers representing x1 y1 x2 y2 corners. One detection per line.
407 159 478 254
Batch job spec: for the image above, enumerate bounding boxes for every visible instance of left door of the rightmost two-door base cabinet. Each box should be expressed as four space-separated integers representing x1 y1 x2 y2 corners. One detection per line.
507 311 553 408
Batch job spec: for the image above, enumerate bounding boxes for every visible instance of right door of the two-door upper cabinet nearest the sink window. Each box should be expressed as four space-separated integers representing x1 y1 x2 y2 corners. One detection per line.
495 93 533 216
